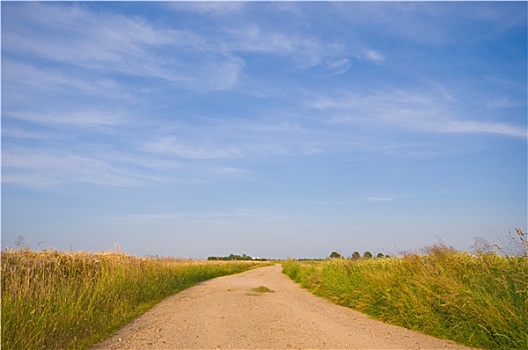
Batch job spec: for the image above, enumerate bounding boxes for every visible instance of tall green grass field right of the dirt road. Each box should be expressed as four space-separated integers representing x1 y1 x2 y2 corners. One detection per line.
283 246 528 349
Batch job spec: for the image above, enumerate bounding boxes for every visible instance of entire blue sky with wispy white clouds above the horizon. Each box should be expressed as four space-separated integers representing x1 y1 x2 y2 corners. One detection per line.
1 2 527 258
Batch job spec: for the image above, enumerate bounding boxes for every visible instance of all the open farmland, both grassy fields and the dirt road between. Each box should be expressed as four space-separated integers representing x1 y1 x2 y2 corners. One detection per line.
2 237 528 349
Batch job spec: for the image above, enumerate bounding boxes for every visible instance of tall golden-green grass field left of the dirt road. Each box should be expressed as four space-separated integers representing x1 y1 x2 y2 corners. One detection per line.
1 249 265 350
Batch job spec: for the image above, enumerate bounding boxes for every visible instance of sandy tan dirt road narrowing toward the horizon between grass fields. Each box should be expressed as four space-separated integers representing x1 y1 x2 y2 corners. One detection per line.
94 265 476 350
